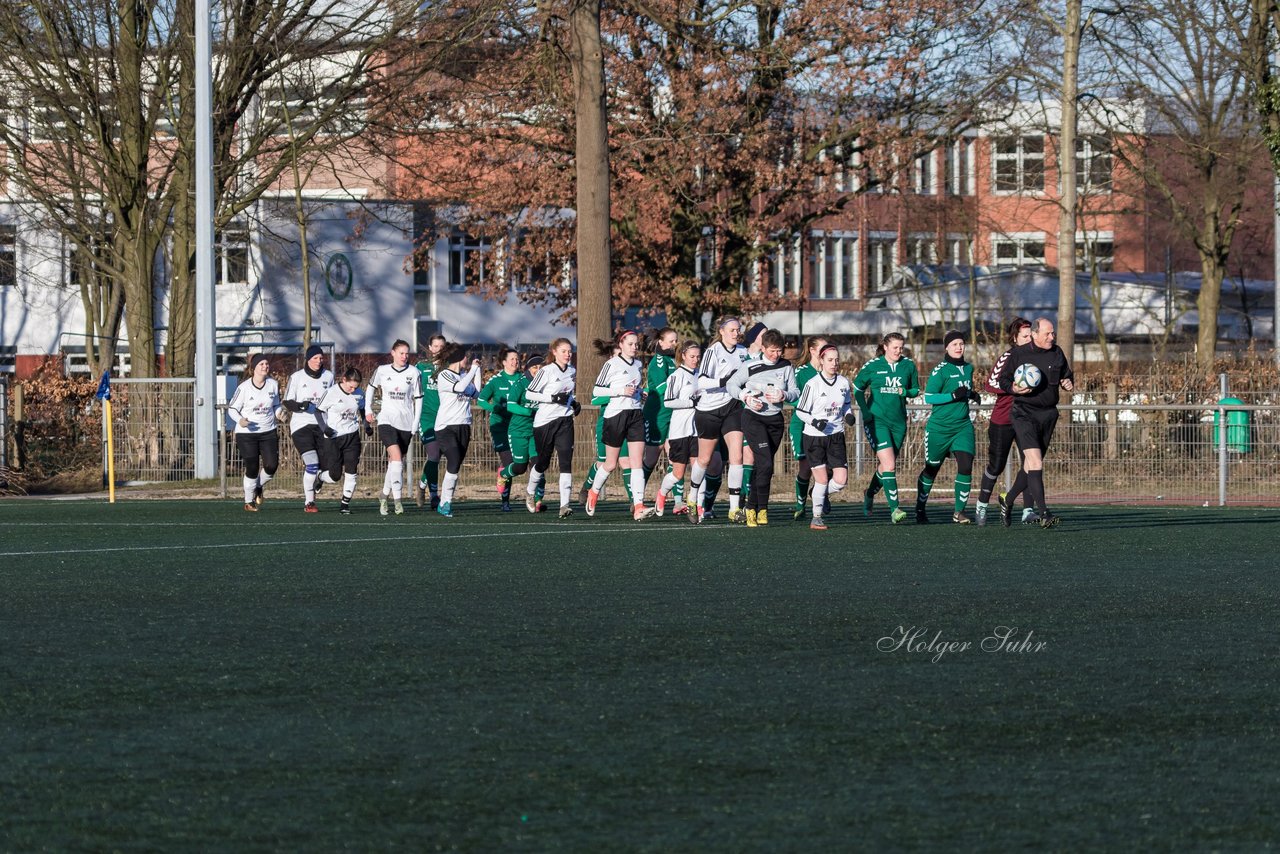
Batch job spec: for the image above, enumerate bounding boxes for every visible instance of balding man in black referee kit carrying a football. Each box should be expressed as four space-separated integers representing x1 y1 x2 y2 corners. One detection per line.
998 318 1075 528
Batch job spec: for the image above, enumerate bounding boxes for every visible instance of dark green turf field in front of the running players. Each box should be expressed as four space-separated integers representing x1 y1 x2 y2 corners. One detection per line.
0 501 1280 851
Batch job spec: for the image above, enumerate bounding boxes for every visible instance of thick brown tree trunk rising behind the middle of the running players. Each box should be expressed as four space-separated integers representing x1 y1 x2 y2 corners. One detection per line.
570 0 613 401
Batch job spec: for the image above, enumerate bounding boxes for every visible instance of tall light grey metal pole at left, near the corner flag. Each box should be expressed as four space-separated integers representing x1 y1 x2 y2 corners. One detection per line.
195 0 218 479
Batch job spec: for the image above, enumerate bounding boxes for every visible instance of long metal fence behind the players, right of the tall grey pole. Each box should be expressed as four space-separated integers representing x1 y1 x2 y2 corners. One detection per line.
212 405 1280 504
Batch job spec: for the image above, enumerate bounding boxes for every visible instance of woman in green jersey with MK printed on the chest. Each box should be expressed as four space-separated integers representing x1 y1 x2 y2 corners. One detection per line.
854 332 920 525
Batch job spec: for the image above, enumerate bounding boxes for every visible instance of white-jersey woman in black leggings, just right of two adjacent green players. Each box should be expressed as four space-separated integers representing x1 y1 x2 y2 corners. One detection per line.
525 338 581 519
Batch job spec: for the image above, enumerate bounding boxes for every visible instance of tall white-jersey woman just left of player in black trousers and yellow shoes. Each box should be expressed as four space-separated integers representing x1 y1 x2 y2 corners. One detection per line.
689 318 748 522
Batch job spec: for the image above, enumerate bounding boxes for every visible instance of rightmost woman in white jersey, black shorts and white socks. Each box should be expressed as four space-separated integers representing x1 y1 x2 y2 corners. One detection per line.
796 344 852 531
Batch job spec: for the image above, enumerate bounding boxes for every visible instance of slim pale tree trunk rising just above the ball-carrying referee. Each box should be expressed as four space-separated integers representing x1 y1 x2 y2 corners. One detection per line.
1057 0 1080 361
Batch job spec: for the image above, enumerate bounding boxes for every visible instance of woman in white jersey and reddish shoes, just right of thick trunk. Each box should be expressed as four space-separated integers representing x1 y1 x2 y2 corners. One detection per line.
586 329 653 521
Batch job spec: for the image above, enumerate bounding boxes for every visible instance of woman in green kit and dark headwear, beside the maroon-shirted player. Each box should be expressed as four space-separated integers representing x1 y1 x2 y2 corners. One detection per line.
915 329 982 525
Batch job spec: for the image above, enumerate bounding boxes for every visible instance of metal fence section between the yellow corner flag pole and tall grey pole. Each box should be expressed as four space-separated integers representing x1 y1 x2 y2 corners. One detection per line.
102 378 196 483
